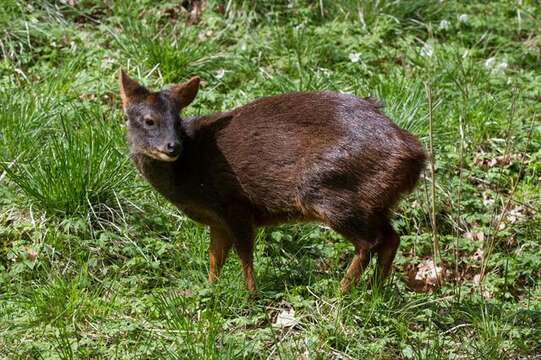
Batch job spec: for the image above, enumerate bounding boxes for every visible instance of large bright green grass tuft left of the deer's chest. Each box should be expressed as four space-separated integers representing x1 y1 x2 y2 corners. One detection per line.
3 107 130 214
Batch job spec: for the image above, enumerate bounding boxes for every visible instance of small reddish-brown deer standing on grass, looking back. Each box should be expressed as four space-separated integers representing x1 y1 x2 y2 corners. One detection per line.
119 70 426 292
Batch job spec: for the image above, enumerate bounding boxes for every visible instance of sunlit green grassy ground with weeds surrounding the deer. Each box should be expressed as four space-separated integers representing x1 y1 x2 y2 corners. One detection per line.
0 0 541 359
